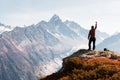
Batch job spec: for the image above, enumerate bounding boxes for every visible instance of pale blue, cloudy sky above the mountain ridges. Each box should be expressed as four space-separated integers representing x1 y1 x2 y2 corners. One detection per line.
0 0 120 35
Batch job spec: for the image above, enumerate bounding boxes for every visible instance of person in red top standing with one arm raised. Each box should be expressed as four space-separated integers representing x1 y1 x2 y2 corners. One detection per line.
88 22 97 50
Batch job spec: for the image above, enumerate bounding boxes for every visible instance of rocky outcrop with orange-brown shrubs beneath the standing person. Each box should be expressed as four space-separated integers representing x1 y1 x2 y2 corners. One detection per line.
40 49 120 80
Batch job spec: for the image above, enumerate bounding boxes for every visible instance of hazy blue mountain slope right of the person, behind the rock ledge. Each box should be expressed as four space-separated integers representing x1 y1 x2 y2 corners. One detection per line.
97 33 120 52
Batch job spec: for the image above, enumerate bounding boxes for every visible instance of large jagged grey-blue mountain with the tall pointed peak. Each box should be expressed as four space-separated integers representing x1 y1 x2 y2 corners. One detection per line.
0 15 107 80
